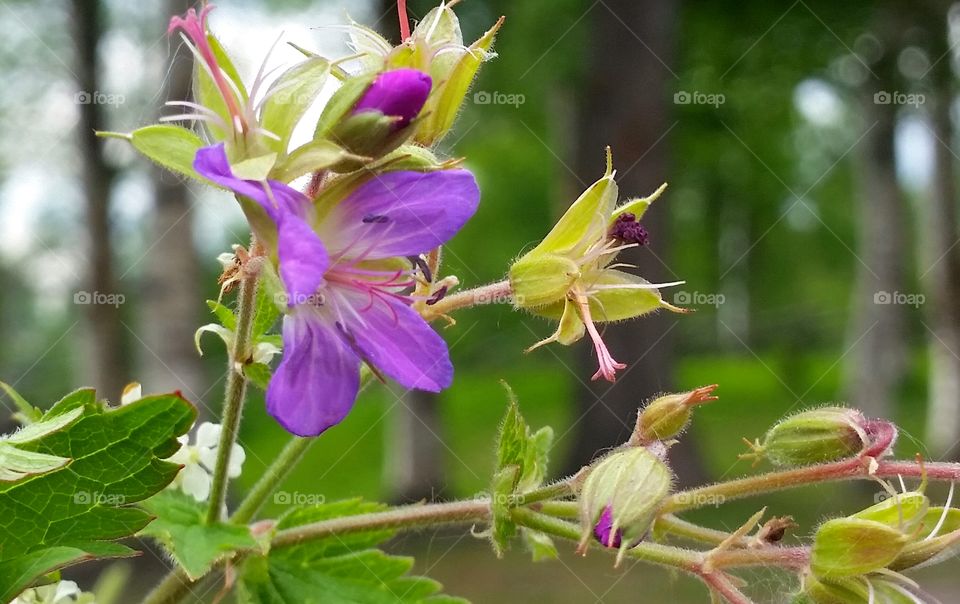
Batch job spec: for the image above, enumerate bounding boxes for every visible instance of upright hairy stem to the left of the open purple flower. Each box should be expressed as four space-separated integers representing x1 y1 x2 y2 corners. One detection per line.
207 248 259 524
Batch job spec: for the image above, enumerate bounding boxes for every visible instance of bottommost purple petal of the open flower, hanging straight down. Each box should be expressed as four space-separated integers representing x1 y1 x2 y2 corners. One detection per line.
267 309 360 436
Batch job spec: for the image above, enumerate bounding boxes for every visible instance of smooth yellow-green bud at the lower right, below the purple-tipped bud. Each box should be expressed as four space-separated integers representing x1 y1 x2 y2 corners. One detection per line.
810 518 909 580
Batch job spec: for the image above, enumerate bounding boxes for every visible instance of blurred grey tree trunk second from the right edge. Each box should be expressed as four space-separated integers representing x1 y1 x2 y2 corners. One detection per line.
847 2 910 417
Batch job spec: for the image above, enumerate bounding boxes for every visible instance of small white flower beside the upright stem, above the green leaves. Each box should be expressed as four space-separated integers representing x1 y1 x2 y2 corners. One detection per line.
170 422 247 501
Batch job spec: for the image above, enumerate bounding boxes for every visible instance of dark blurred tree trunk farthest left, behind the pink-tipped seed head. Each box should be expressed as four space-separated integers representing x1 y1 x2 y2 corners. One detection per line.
71 0 130 398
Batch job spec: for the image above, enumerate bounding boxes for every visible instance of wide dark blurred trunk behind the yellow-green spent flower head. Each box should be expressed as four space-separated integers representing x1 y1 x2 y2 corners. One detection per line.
567 0 702 482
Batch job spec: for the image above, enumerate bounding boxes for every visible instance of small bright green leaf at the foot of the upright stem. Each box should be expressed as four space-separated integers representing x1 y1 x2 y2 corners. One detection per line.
140 490 257 579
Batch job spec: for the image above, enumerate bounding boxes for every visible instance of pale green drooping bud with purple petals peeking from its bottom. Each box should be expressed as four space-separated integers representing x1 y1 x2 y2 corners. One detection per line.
578 447 673 564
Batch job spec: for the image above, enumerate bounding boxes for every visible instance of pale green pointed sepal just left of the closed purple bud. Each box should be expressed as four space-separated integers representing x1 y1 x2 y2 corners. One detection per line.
260 57 330 154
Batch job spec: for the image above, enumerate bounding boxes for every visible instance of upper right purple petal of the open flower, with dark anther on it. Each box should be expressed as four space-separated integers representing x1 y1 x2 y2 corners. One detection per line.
320 170 480 259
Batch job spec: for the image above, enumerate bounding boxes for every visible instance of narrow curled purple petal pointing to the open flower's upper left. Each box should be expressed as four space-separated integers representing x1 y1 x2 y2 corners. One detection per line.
193 143 310 222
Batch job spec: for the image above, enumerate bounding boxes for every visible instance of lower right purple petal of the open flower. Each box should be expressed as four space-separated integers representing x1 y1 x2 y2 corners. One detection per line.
336 287 453 392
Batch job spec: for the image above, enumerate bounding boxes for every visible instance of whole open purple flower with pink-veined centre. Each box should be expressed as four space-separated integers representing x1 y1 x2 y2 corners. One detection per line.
194 145 480 436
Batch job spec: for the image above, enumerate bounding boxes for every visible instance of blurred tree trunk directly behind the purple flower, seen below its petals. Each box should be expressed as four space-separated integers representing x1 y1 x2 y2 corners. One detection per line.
373 0 445 502
